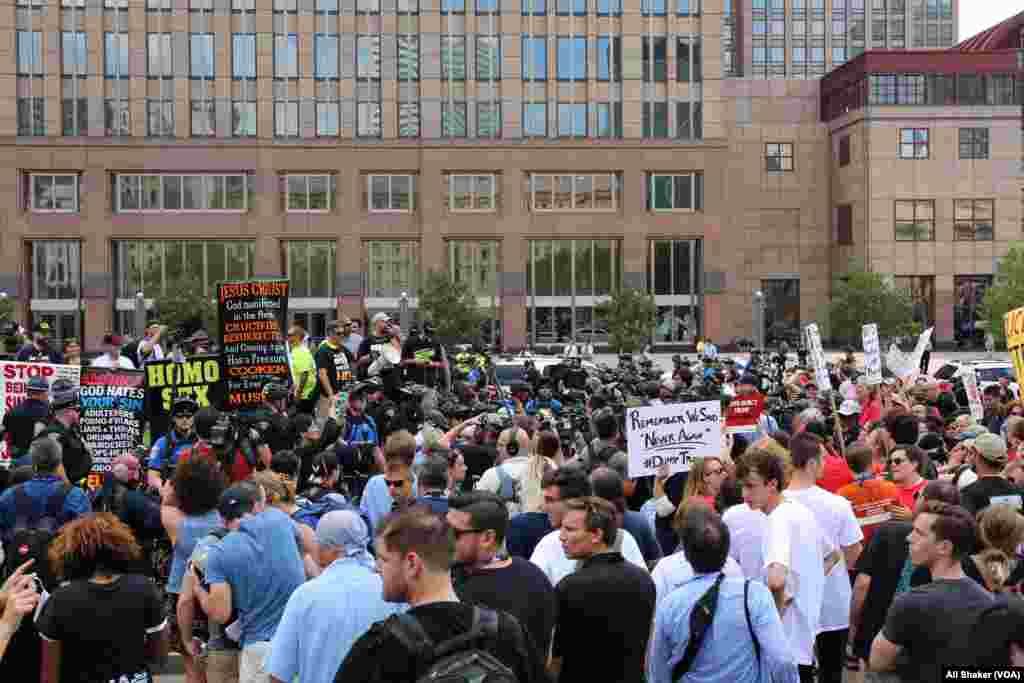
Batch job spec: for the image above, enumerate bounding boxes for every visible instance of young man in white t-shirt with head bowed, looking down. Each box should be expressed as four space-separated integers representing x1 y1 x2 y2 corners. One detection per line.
736 449 834 683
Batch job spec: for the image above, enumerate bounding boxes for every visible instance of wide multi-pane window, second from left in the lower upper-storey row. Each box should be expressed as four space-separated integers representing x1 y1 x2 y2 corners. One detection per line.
114 173 252 213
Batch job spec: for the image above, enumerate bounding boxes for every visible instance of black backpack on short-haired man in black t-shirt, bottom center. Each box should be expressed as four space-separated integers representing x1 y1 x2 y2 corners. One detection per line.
385 607 519 683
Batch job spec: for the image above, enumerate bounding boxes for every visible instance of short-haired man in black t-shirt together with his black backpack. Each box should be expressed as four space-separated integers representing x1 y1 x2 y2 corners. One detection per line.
334 507 547 683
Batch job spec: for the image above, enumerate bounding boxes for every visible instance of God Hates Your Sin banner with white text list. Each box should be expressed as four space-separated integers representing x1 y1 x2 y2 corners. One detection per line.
79 368 145 488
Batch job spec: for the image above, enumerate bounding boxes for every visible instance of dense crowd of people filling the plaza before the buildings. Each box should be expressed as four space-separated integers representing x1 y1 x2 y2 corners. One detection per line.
0 313 1024 683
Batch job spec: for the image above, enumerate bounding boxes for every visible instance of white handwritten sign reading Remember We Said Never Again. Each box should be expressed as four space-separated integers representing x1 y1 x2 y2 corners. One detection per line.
626 400 722 479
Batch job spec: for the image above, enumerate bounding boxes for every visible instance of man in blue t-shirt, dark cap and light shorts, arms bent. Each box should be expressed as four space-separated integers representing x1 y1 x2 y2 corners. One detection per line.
193 481 306 681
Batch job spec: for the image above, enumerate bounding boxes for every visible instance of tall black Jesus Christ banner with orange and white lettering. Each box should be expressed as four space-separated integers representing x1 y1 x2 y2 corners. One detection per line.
217 280 292 410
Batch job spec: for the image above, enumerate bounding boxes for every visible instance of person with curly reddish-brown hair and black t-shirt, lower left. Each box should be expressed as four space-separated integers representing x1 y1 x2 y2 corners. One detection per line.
36 512 168 683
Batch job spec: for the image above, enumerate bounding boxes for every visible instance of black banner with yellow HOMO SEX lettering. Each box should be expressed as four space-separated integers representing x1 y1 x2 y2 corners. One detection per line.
145 354 221 442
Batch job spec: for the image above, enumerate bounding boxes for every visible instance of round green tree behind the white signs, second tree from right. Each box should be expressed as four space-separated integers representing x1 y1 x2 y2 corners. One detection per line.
828 270 921 347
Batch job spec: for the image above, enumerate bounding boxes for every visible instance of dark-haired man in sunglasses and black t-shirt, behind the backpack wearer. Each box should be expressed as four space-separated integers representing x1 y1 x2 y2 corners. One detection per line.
447 490 556 652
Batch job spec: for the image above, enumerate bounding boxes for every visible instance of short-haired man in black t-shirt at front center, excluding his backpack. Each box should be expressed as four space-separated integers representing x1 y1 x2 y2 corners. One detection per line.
335 507 544 683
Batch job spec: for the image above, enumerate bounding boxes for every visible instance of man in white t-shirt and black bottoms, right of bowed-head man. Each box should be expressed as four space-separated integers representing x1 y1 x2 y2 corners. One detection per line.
785 431 864 683
